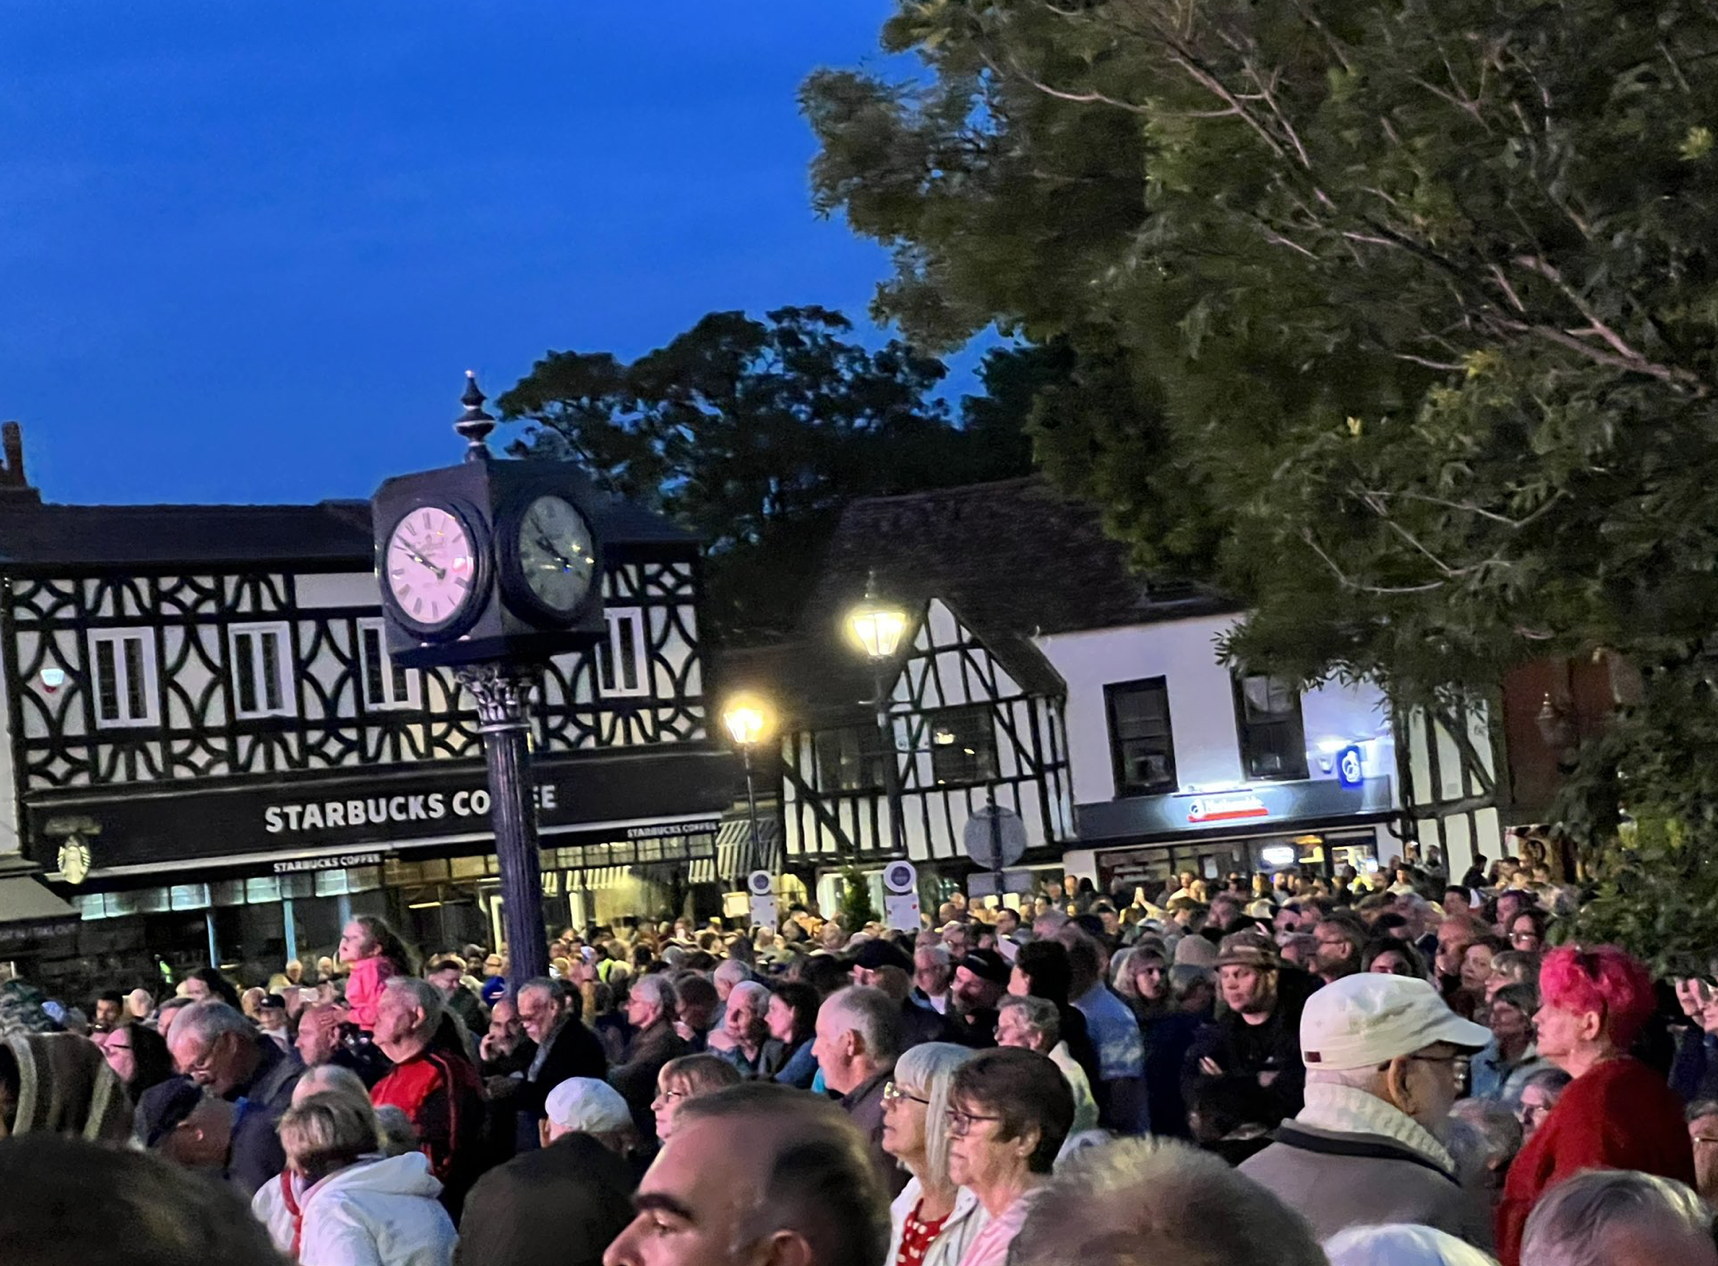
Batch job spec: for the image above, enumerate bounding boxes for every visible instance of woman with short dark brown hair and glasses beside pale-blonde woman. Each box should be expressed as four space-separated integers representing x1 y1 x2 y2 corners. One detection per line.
947 1048 1074 1266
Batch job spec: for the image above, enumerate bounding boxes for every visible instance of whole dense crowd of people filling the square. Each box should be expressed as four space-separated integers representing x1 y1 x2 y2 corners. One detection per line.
0 859 1718 1266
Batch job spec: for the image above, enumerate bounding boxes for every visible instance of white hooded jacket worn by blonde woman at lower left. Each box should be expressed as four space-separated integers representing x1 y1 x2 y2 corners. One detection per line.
251 1151 459 1266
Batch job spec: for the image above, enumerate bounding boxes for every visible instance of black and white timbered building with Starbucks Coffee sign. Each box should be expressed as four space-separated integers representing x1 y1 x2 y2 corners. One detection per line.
0 428 737 979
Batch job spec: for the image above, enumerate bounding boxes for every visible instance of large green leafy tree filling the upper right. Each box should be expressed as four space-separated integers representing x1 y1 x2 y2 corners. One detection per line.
802 0 1718 955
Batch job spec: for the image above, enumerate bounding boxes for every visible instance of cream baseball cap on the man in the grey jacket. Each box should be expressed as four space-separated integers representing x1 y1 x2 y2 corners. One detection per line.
1301 972 1491 1072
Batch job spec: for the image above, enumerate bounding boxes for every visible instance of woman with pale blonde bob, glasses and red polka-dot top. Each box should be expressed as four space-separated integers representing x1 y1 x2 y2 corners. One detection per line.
883 1043 983 1266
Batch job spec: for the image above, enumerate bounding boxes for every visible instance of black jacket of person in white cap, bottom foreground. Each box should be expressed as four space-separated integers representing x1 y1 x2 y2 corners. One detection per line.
454 1134 636 1266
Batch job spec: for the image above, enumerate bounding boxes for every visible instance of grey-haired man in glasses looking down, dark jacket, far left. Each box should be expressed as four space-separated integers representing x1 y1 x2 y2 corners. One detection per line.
167 1001 304 1199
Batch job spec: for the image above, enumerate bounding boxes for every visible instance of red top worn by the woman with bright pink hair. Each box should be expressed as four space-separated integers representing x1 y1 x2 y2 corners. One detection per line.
1496 1058 1694 1266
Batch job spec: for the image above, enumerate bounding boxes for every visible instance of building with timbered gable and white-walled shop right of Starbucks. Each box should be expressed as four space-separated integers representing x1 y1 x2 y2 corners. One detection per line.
725 479 1495 909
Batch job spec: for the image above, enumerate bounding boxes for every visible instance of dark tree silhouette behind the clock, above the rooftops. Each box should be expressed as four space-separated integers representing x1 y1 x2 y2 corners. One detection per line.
498 307 1031 637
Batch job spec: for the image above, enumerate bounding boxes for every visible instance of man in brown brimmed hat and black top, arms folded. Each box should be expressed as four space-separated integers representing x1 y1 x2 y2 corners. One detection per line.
1185 929 1313 1125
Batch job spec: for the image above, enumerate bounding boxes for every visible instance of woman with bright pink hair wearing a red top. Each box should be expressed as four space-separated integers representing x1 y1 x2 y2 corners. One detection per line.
1496 945 1694 1266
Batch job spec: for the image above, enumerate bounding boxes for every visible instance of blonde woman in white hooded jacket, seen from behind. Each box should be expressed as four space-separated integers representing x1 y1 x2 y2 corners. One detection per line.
251 1091 457 1266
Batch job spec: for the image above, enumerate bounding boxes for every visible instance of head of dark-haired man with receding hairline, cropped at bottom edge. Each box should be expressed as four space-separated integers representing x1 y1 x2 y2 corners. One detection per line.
603 1078 892 1266
